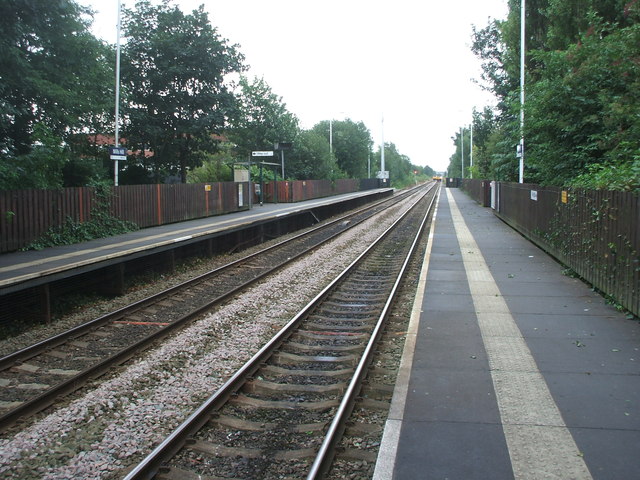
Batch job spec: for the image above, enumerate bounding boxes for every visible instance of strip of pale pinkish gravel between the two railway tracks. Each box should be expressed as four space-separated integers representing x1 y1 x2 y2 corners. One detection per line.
0 196 418 480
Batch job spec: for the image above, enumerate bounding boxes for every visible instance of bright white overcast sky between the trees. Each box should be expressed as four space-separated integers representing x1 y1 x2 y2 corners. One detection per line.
77 0 507 171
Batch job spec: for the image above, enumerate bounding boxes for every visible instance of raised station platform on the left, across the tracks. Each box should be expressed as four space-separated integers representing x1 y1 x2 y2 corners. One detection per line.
0 188 393 300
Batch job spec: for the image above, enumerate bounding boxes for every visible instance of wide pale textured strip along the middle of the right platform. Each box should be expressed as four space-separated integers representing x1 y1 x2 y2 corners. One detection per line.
447 189 592 480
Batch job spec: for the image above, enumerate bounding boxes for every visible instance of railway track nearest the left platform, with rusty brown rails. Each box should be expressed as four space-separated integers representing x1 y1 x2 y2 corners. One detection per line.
0 185 432 430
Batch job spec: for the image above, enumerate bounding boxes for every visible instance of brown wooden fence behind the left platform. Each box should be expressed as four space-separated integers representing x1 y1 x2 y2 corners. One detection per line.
0 179 378 253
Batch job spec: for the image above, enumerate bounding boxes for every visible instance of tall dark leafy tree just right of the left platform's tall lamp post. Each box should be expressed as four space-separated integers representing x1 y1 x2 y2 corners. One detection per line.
122 0 245 182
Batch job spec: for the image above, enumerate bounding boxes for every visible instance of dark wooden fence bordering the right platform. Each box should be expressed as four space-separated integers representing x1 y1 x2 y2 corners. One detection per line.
463 180 640 316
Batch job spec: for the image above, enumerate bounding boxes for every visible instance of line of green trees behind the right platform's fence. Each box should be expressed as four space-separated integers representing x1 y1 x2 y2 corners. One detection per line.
449 0 640 191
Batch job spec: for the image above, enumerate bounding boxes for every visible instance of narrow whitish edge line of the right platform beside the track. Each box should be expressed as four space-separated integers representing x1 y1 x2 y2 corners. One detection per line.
373 187 440 480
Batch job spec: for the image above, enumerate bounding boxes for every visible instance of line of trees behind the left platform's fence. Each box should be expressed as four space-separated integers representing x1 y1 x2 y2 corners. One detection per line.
0 0 433 190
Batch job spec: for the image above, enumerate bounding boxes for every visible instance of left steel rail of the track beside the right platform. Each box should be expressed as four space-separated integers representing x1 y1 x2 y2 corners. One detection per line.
124 184 436 480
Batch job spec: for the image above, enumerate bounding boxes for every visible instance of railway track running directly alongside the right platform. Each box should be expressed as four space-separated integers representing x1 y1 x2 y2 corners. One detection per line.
126 182 436 480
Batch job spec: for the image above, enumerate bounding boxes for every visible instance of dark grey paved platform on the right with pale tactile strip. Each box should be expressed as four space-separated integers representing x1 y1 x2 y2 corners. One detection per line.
374 188 640 480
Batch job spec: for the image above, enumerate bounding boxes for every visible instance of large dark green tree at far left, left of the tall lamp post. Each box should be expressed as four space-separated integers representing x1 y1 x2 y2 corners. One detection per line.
0 0 114 188
